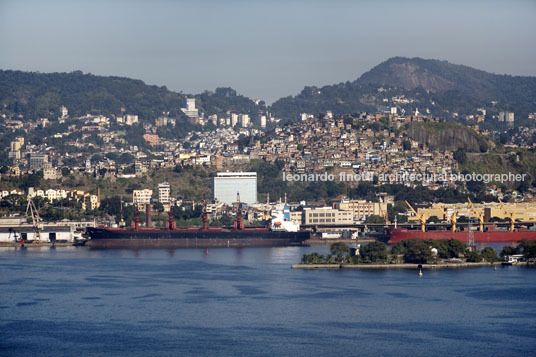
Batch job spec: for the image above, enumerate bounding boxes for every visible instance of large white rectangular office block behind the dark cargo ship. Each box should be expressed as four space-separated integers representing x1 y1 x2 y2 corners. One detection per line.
212 172 257 205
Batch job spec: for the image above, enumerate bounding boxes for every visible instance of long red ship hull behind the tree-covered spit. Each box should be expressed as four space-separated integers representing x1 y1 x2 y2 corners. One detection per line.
388 228 536 244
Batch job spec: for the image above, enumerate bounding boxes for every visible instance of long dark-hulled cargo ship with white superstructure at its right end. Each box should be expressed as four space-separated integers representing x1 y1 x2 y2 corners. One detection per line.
86 203 311 248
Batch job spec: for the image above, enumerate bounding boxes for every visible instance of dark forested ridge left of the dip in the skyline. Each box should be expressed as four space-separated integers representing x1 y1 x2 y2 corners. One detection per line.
0 70 264 121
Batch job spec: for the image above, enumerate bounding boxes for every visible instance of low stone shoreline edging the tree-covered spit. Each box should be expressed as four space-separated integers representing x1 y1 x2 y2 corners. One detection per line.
291 262 529 270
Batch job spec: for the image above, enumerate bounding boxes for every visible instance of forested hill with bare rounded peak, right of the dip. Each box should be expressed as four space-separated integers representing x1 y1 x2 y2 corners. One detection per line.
271 57 536 119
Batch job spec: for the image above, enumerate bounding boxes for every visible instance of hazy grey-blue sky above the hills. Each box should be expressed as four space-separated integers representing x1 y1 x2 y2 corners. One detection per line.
0 0 536 102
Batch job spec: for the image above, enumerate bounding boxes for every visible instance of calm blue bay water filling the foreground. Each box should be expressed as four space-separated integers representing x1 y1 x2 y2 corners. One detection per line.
0 247 536 356
